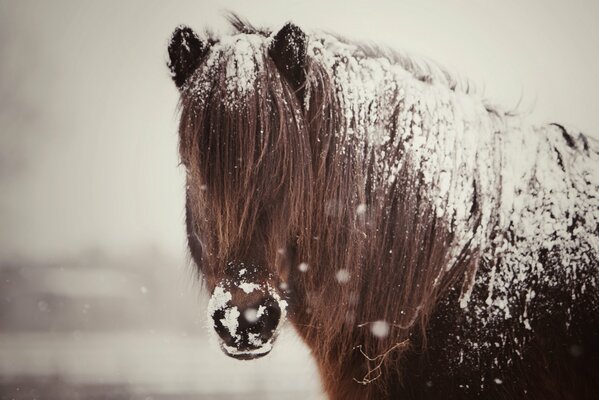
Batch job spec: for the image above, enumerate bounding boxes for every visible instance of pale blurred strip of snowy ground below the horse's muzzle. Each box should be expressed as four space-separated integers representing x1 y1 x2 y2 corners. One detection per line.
0 332 320 399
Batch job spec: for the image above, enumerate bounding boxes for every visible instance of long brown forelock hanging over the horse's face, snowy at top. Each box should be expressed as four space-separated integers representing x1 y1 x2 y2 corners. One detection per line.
180 37 312 268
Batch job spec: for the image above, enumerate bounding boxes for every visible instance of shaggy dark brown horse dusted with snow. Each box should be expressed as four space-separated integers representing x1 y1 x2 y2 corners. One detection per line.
168 16 599 400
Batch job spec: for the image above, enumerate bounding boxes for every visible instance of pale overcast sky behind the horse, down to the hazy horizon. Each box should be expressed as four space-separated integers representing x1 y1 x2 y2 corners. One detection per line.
0 0 599 258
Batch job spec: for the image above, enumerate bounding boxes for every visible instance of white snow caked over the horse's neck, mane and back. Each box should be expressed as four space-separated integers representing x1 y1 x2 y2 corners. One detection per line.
308 31 599 360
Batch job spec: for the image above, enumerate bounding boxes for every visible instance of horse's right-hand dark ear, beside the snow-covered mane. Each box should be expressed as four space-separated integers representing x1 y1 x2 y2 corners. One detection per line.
269 22 307 90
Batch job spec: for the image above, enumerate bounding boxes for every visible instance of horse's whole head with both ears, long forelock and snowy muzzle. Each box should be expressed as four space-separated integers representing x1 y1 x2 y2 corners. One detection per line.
168 24 311 359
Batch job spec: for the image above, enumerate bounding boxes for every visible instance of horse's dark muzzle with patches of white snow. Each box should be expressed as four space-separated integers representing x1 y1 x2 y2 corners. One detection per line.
208 269 287 360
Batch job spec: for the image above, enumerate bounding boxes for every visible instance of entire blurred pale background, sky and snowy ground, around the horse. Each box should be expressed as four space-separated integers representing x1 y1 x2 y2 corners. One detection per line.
0 0 599 400
